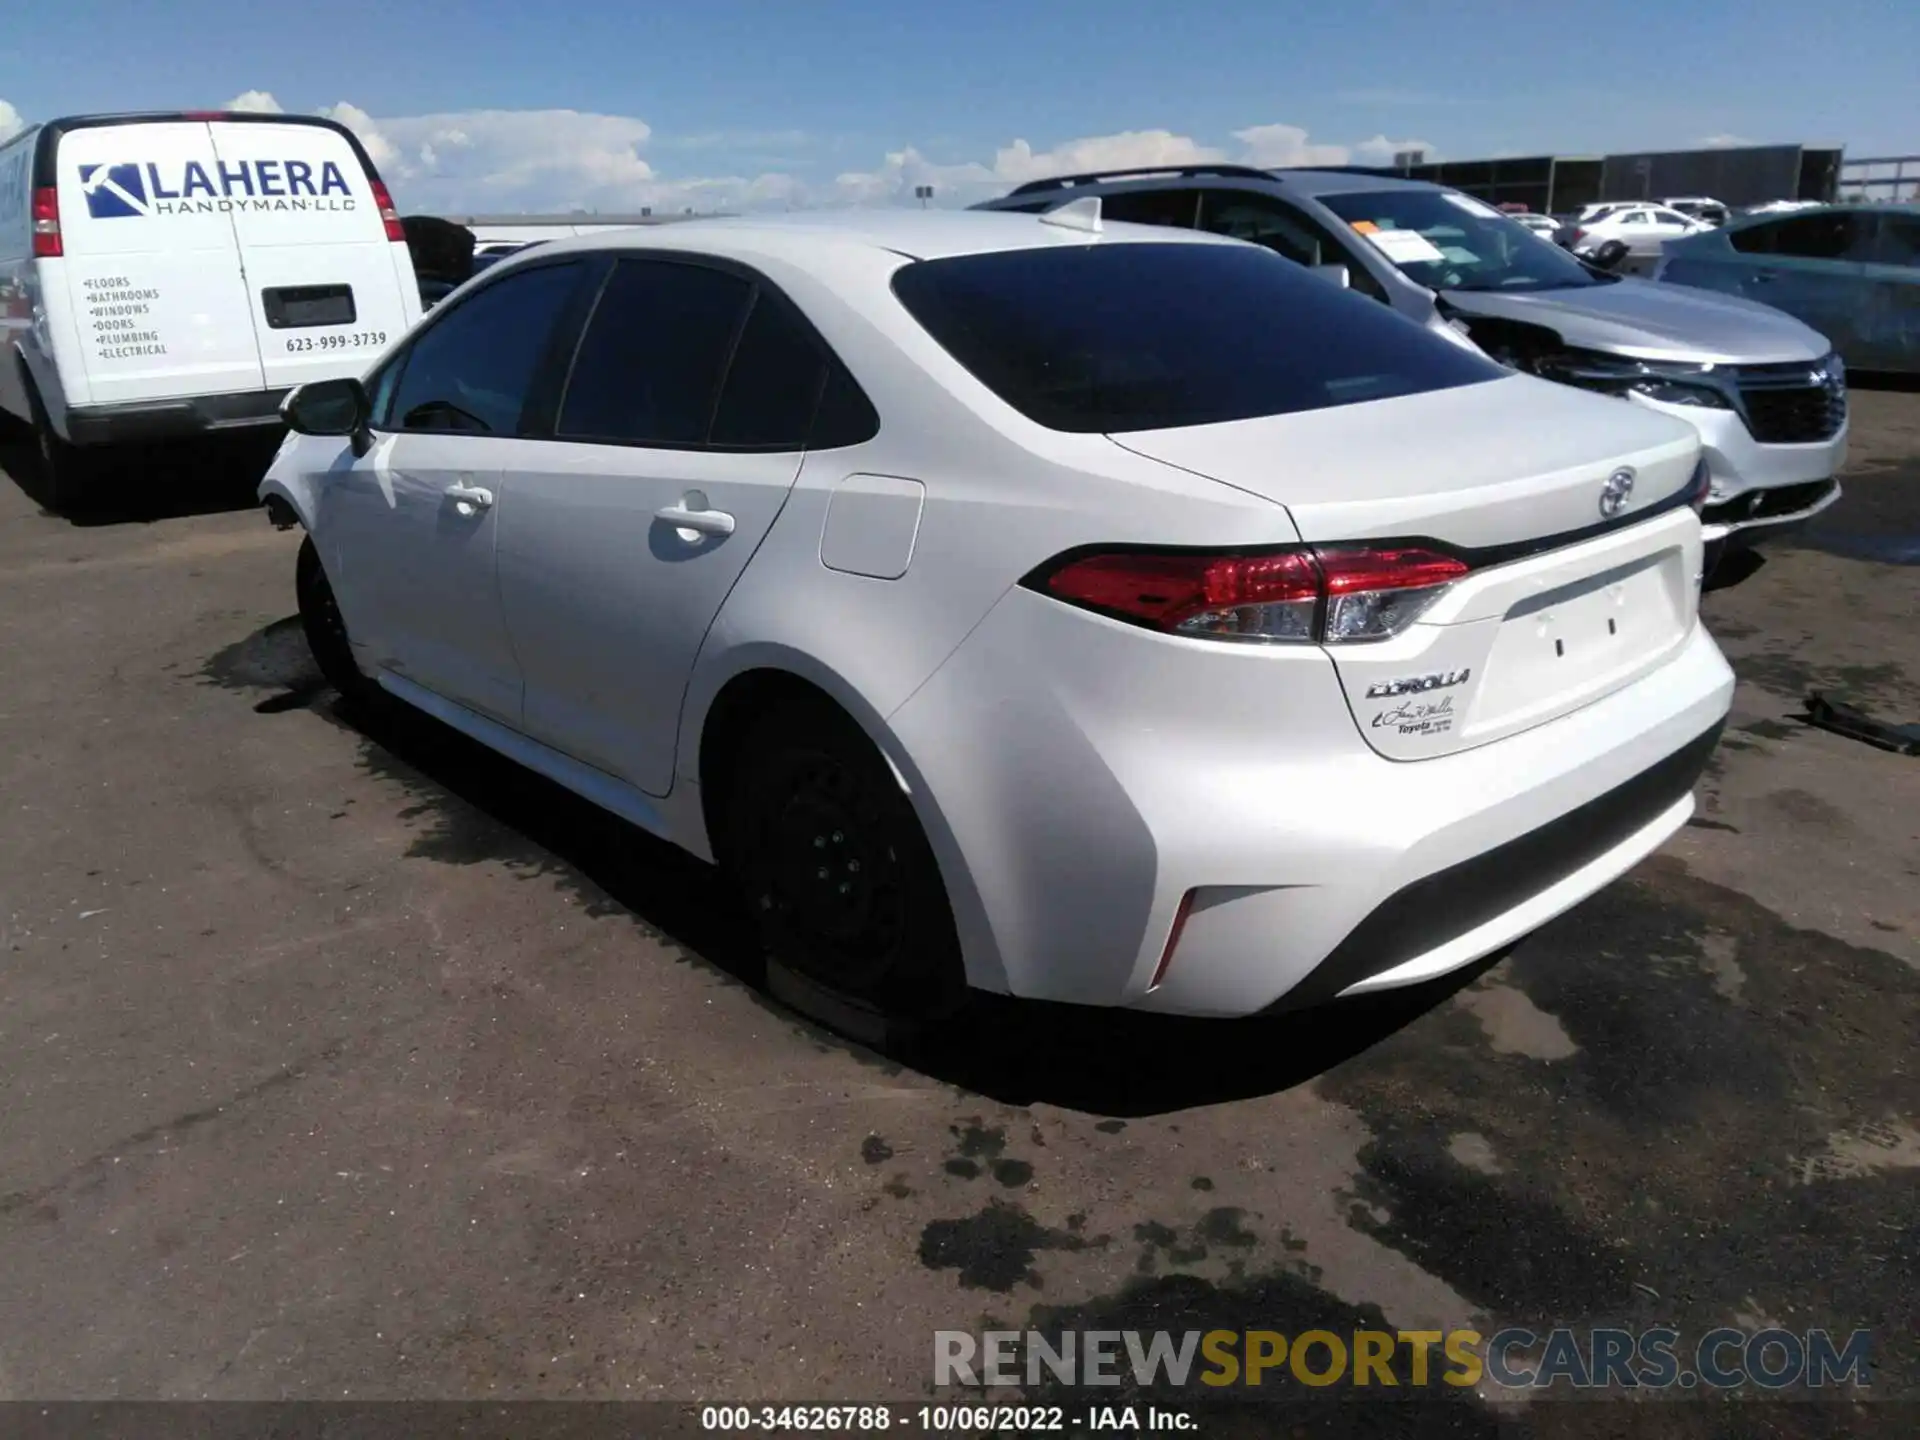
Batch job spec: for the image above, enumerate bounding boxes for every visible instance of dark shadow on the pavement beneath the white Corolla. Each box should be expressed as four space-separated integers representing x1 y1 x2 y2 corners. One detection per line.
202 616 1500 1117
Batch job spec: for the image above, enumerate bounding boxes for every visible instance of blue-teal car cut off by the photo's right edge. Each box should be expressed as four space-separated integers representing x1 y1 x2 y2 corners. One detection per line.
1655 205 1920 374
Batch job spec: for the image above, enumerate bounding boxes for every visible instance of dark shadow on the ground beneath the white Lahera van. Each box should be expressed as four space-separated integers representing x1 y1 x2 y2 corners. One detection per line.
0 430 280 528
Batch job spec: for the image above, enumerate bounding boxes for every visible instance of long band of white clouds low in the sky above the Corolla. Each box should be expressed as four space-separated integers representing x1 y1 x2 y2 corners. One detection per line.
206 90 1432 215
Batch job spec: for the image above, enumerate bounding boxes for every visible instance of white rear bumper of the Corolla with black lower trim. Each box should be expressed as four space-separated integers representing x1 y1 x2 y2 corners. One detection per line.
891 591 1734 1016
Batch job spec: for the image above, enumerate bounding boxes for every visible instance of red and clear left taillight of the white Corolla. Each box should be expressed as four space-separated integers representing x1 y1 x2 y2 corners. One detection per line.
1025 547 1467 645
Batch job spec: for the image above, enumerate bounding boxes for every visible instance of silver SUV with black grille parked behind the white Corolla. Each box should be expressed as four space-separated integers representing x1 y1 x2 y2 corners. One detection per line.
981 165 1847 584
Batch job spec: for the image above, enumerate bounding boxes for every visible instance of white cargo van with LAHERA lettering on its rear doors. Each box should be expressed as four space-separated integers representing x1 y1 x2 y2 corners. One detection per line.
0 111 420 507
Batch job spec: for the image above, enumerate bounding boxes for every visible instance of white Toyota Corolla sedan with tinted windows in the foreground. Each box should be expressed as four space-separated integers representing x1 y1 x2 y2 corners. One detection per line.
261 202 1734 1018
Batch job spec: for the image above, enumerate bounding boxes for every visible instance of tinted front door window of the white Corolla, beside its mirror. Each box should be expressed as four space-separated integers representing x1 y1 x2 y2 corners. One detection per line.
374 261 582 436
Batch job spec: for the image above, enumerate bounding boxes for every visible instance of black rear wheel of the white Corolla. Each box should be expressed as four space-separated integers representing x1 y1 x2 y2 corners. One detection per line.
720 703 966 1039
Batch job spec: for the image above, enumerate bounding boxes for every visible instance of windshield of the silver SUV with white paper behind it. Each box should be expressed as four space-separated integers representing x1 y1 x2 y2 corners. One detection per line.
1319 188 1613 292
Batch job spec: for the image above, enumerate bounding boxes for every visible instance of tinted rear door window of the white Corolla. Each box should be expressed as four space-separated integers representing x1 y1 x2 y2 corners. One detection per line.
555 259 753 447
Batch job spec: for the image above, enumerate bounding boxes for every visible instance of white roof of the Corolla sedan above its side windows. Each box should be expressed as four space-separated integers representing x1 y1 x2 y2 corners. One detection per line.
510 209 1236 259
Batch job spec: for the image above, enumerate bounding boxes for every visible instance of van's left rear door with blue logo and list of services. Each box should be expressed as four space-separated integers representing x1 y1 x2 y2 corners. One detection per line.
54 119 265 405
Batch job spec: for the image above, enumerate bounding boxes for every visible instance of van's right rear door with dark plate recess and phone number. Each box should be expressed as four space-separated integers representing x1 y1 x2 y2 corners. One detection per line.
207 117 420 390
